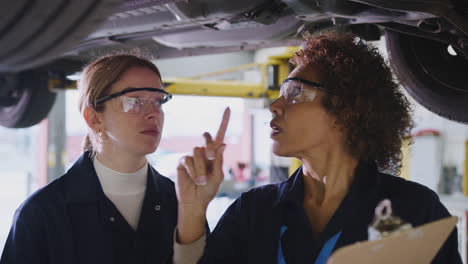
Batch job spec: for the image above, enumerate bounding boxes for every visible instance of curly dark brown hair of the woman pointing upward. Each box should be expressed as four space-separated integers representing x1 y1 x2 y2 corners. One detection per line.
290 31 414 173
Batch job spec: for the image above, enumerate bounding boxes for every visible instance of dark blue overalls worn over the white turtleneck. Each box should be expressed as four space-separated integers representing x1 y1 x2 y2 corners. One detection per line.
0 153 177 264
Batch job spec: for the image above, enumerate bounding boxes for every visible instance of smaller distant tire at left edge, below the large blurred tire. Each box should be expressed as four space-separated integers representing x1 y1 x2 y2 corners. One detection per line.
0 71 56 128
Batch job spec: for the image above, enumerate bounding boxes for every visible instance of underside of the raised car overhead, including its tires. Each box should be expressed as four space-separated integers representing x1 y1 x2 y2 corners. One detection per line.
0 0 468 127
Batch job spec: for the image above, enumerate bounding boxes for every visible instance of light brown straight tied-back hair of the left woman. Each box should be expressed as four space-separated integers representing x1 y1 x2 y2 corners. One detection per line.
78 54 161 155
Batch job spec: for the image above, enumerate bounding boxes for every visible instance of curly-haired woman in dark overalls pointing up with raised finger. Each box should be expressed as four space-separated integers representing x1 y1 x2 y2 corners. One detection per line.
176 31 461 263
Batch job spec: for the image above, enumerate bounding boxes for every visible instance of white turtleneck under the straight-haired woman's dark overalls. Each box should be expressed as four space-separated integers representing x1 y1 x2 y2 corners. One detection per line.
93 158 148 230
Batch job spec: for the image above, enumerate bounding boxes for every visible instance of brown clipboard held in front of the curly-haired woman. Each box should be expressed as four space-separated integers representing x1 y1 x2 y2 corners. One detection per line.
327 216 457 264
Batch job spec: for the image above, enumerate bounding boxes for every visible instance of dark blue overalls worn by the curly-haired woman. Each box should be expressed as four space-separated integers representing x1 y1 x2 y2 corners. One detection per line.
199 162 461 264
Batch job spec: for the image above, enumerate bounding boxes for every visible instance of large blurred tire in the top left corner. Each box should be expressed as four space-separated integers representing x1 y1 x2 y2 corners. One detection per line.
0 0 121 72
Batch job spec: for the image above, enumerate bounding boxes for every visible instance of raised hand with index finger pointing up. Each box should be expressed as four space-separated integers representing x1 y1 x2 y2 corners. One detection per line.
176 108 231 243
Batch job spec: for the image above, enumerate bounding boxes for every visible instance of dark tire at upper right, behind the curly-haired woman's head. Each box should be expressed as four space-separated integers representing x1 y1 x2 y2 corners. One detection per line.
385 30 468 123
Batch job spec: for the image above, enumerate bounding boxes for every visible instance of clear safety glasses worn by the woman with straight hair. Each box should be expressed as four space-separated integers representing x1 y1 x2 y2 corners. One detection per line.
95 88 172 114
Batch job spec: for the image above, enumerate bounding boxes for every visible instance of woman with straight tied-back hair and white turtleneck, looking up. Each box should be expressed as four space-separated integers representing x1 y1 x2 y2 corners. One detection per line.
0 54 230 264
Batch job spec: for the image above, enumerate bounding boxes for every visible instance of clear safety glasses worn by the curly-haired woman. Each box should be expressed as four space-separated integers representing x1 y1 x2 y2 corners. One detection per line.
280 77 331 104
